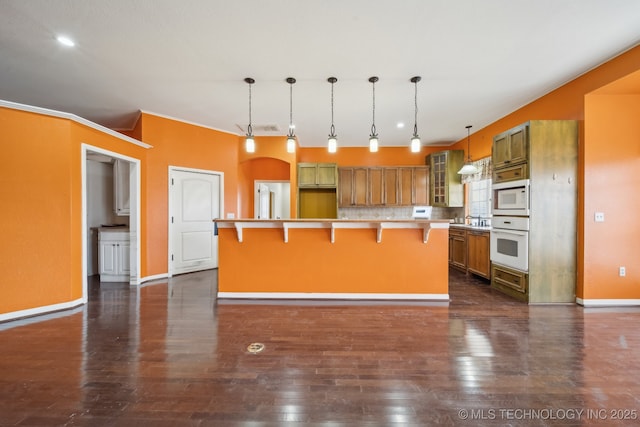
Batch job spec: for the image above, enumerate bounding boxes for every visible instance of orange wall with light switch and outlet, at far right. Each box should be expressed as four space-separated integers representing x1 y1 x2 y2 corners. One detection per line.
579 91 640 299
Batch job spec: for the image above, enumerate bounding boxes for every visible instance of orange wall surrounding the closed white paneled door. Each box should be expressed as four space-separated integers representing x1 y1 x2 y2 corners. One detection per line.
141 113 238 277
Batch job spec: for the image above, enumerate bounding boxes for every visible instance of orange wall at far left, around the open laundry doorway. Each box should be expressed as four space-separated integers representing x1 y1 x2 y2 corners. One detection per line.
0 107 145 314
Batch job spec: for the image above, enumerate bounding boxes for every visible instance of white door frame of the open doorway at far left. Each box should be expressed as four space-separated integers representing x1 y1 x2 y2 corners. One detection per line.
80 142 141 304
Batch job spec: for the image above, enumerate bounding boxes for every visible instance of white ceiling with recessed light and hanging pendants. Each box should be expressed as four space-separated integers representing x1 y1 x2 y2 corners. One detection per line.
0 0 640 147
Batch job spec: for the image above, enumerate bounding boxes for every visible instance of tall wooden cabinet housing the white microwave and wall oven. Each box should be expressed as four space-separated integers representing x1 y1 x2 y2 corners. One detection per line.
491 120 578 303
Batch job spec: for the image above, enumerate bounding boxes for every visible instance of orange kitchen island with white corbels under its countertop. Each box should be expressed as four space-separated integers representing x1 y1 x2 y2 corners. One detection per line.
214 219 449 301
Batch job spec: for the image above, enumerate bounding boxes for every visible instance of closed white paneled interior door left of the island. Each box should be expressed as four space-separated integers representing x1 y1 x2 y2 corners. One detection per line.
169 169 221 274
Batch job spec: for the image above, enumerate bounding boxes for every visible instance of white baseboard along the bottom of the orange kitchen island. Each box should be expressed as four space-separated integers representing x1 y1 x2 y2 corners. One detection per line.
218 292 449 301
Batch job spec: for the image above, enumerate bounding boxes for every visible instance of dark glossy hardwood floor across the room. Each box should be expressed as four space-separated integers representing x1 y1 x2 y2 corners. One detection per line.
0 270 640 427
